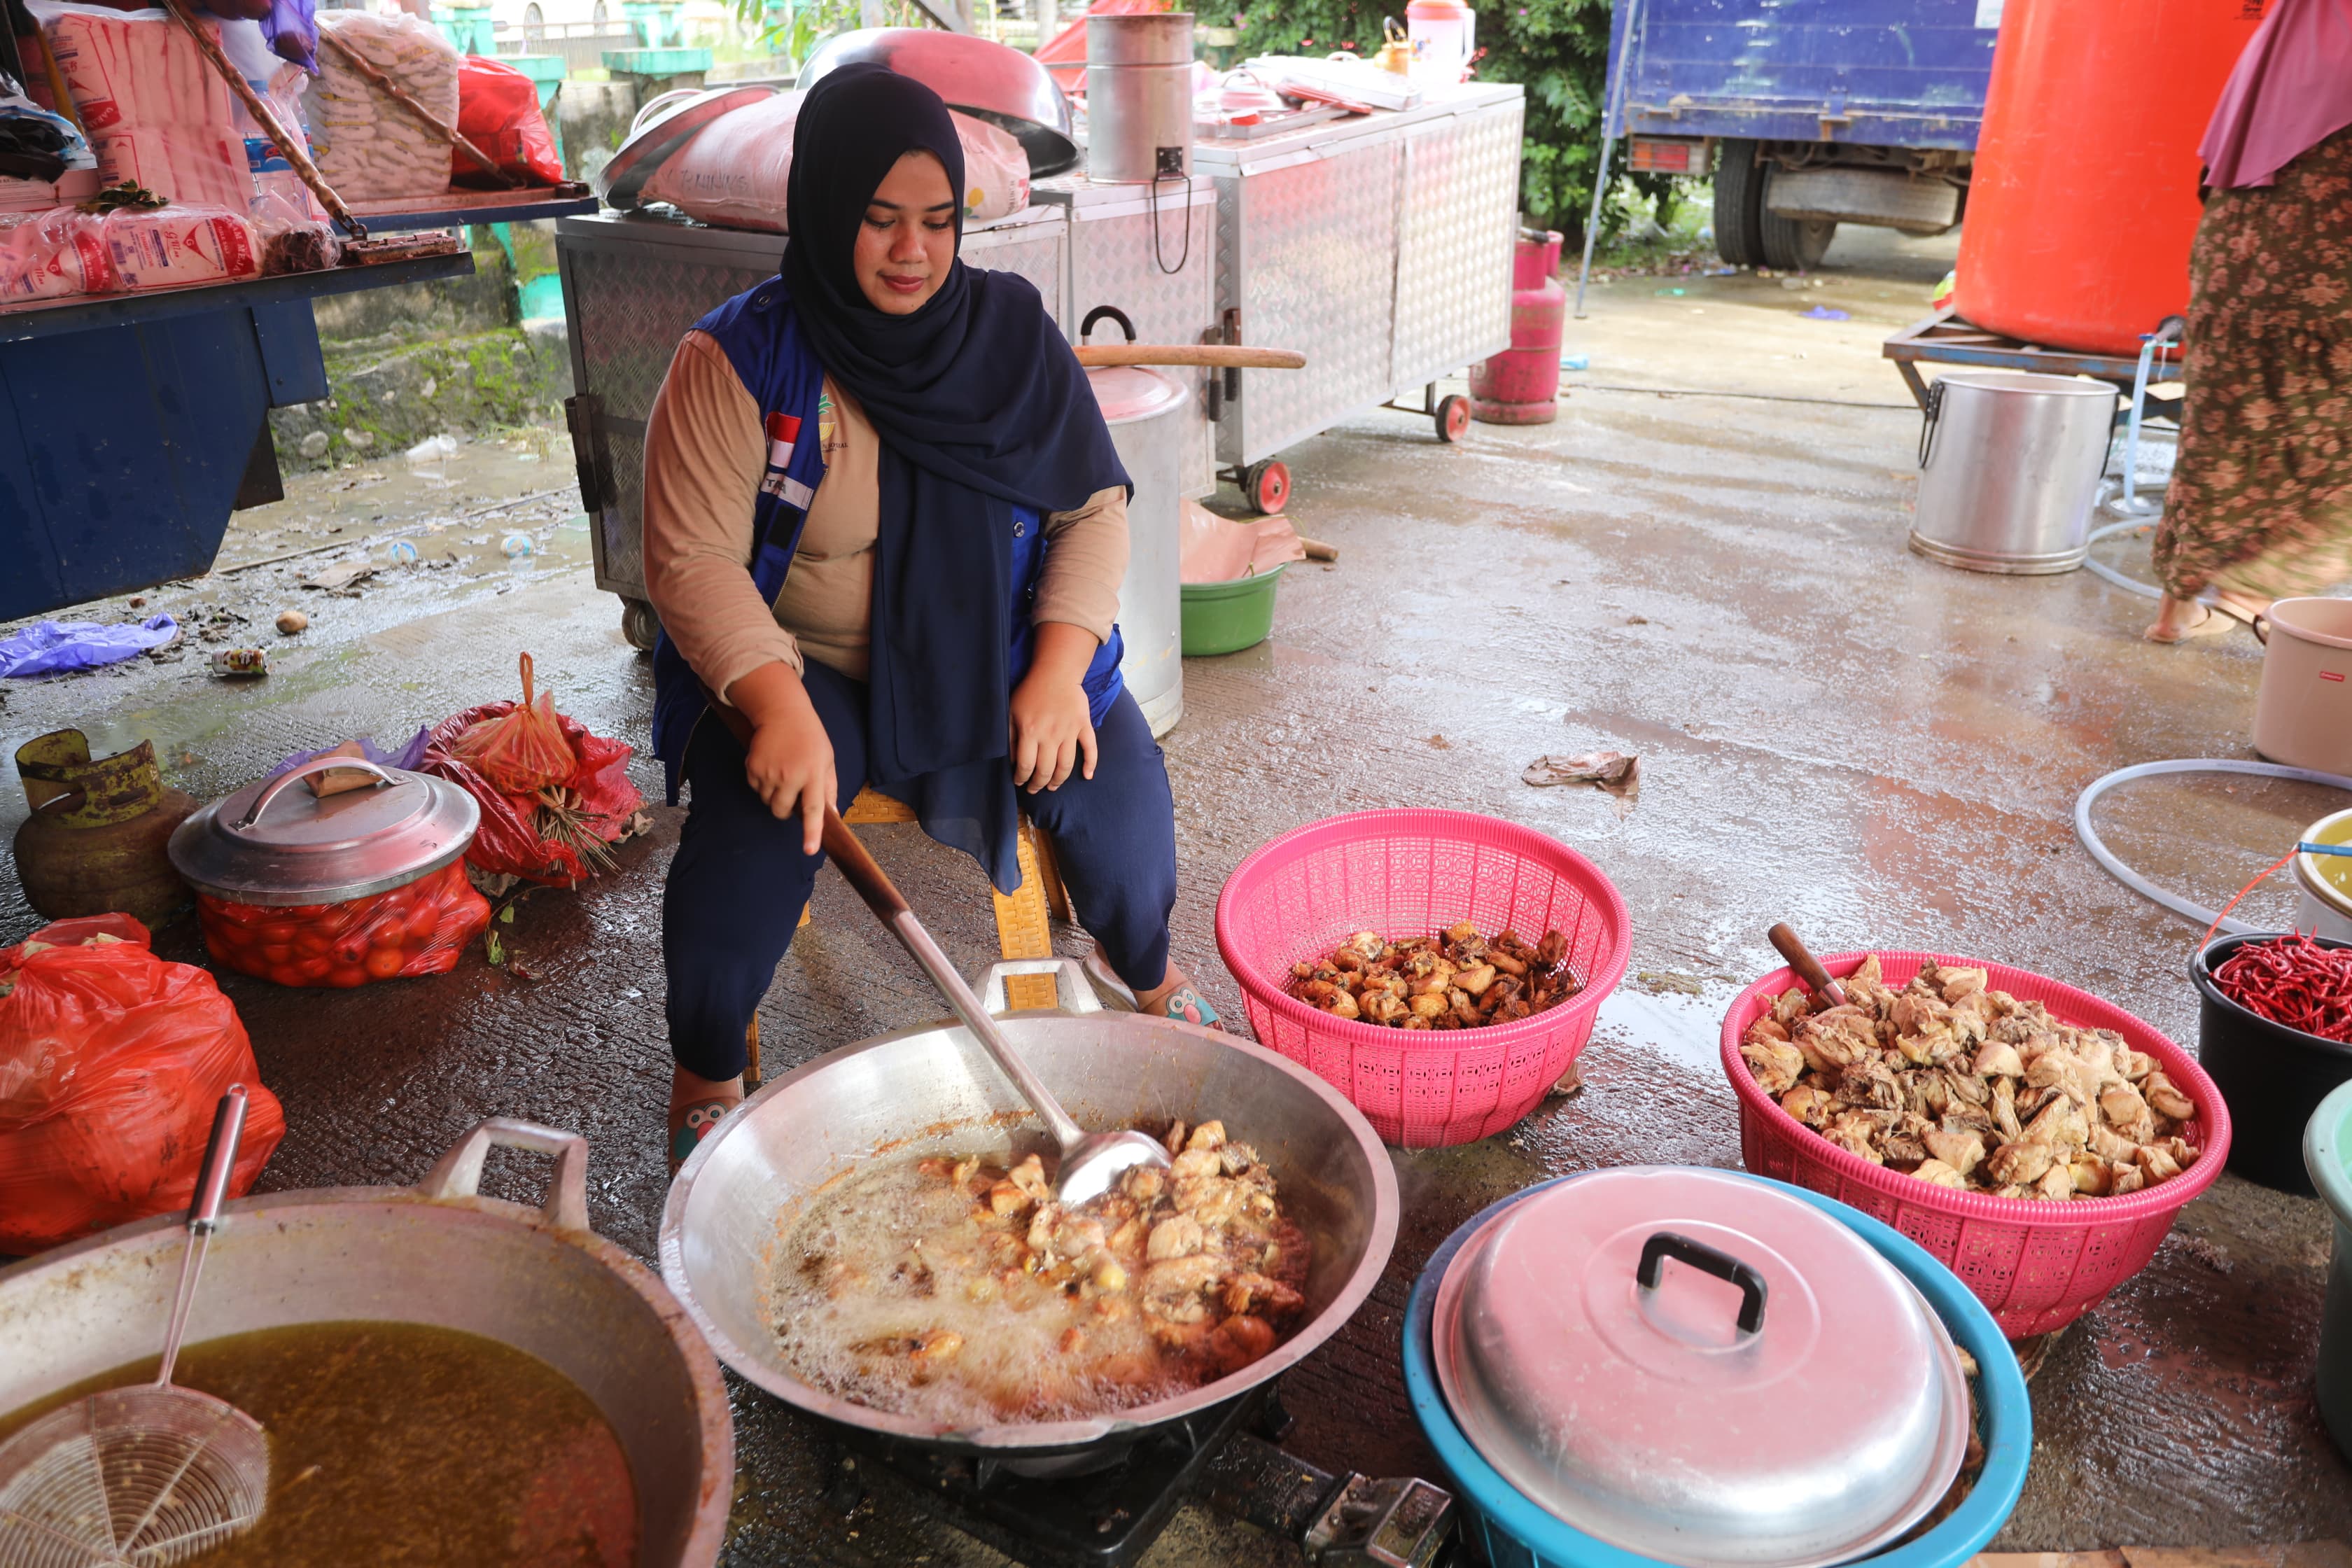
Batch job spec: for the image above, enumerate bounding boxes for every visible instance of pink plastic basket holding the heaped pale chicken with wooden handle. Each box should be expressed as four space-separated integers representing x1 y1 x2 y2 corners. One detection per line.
1724 952 2230 1340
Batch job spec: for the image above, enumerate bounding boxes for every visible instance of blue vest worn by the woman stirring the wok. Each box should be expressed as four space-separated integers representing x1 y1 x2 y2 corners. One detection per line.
654 277 1126 884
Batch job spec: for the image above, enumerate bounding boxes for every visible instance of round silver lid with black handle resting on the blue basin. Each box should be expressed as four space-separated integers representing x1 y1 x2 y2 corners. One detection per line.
1432 1166 1968 1568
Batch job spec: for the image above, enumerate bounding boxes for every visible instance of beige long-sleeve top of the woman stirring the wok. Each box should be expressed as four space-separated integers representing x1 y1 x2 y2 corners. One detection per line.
645 332 1126 701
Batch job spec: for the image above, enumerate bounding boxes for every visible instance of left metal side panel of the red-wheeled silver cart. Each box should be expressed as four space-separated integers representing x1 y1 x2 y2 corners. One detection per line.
1216 136 1402 463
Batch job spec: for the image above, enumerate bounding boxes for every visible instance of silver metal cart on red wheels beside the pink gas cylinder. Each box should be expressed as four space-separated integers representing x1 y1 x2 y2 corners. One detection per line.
1193 83 1527 510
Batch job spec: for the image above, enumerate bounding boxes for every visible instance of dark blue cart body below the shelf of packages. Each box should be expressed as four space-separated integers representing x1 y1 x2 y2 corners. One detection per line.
0 251 472 621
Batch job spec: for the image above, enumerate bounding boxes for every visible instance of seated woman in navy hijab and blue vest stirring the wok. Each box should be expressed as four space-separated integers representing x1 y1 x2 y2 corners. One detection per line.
645 66 1216 1163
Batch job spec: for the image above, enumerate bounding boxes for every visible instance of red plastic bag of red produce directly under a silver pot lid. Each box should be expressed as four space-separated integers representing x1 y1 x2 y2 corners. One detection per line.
195 860 489 987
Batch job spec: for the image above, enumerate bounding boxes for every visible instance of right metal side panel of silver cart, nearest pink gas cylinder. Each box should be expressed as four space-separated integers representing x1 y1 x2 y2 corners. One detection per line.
1390 97 1524 393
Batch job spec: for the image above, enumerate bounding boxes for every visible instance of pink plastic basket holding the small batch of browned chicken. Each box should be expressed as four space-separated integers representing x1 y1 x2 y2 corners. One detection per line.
1216 811 1628 1149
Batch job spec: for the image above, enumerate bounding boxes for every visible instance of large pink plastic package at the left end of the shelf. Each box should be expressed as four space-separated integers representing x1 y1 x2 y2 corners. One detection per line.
28 0 254 211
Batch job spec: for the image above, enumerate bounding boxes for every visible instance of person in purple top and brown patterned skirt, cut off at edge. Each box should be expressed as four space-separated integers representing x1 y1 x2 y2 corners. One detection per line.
2148 0 2352 642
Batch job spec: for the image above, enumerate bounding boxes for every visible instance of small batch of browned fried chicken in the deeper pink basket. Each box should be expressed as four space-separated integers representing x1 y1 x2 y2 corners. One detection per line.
1284 921 1583 1030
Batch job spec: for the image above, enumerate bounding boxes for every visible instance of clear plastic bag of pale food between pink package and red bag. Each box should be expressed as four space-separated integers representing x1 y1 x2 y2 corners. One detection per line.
308 12 458 202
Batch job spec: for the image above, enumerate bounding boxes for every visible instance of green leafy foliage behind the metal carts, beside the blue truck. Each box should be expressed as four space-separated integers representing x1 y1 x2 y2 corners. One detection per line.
1235 0 1670 244
